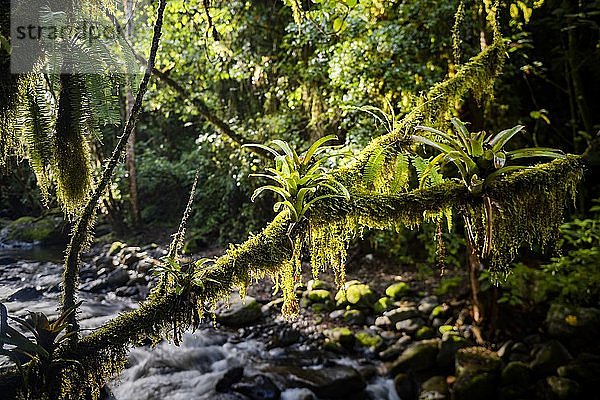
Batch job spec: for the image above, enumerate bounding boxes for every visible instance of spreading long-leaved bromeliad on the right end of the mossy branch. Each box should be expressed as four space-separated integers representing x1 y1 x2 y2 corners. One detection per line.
412 118 565 195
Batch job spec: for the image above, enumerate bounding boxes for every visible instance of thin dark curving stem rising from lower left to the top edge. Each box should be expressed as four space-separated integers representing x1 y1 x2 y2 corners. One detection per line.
61 0 167 342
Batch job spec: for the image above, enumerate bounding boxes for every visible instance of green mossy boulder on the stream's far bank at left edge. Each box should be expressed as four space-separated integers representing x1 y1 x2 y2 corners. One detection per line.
6 213 69 246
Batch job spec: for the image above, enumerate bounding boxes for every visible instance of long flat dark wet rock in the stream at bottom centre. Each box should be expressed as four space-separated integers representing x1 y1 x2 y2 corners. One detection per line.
267 365 366 399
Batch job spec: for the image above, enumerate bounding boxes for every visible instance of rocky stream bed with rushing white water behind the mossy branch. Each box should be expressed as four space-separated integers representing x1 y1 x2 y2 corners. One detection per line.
0 246 400 400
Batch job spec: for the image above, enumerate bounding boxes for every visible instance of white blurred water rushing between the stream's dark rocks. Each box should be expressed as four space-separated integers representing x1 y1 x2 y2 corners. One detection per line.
0 242 399 400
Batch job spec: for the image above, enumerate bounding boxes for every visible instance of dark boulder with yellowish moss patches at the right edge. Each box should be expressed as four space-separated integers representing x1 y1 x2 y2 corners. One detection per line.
546 303 600 350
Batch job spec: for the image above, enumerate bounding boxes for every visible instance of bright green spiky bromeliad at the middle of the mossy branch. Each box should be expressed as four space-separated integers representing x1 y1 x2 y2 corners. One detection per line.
245 135 350 223
